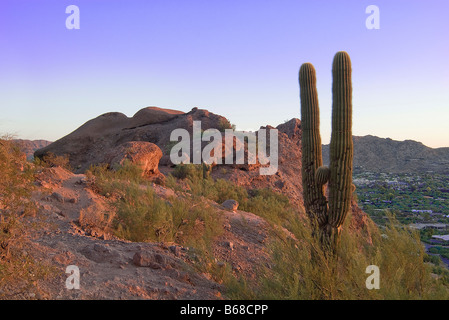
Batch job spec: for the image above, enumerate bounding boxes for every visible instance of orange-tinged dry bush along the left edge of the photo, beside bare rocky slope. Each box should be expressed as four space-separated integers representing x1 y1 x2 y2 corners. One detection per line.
0 136 51 299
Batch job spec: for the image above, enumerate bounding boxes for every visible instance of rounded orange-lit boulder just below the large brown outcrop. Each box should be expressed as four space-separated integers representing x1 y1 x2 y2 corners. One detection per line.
105 141 162 175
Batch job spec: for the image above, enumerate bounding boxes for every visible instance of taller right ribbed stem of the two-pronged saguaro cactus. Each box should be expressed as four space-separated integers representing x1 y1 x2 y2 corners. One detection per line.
327 52 353 241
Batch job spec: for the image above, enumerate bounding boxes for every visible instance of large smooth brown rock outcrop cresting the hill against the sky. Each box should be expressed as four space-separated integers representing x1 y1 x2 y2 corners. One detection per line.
34 107 227 173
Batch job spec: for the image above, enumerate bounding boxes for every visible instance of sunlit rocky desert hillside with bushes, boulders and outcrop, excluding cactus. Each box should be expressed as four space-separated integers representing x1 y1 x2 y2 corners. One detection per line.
0 107 444 300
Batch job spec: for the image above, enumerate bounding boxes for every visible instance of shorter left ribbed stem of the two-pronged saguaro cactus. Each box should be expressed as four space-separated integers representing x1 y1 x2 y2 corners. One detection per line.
299 63 327 226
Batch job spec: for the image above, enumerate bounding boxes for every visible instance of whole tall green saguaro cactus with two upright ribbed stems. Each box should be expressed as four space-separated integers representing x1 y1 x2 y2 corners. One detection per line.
299 51 353 242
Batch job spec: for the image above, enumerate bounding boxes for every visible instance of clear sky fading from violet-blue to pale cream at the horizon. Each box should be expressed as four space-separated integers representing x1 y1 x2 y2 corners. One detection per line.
0 0 449 147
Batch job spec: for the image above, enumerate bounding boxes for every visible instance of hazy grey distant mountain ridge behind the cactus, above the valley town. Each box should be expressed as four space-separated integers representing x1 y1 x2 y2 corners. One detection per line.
323 135 449 174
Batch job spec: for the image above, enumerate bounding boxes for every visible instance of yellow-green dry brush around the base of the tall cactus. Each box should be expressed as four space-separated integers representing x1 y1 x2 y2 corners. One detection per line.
229 212 449 300
